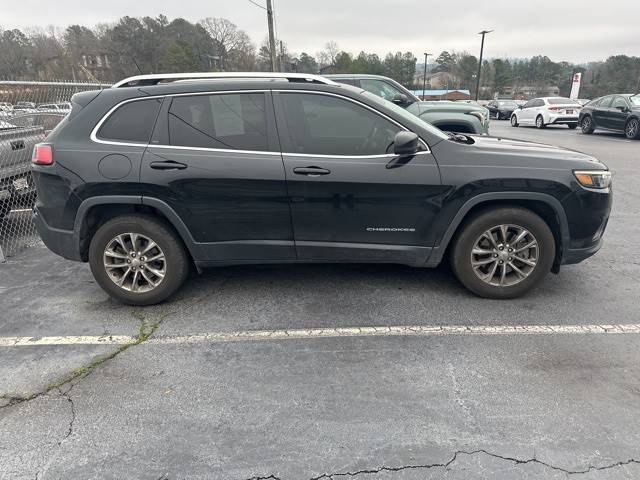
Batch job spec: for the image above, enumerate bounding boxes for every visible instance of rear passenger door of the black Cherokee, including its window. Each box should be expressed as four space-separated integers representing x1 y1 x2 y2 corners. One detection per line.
141 91 295 261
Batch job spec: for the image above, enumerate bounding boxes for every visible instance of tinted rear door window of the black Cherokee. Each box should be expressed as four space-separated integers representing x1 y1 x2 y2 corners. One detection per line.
169 93 269 151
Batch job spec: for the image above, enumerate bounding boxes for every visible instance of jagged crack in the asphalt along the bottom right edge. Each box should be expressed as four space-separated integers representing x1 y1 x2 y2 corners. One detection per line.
304 449 640 480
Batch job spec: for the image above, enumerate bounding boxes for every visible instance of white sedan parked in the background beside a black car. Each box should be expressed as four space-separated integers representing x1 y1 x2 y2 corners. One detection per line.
511 97 582 129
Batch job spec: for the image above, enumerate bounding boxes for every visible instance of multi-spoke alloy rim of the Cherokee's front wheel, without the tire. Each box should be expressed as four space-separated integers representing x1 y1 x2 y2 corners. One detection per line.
471 225 539 287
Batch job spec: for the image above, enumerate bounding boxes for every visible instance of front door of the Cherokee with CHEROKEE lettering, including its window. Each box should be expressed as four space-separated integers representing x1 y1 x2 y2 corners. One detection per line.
274 92 441 263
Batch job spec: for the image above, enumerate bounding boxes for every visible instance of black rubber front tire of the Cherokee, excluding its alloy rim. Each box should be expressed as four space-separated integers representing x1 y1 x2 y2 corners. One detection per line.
450 207 556 299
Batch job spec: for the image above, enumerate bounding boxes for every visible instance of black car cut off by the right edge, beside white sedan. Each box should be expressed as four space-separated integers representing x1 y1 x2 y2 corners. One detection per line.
580 94 640 140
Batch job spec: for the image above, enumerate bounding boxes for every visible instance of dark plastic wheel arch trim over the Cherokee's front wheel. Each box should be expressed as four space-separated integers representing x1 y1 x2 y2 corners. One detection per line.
427 192 570 272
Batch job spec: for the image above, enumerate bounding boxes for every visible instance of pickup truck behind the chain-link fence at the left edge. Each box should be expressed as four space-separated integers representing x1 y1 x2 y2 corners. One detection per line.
0 120 44 221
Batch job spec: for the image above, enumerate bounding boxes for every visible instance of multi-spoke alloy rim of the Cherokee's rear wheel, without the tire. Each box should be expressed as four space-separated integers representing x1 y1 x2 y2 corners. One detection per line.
103 233 167 293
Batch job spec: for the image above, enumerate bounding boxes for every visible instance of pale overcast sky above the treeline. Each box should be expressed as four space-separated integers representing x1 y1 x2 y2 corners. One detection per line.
0 0 640 62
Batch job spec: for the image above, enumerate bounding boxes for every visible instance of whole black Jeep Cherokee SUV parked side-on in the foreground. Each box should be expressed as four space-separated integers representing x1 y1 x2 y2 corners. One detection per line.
33 74 611 305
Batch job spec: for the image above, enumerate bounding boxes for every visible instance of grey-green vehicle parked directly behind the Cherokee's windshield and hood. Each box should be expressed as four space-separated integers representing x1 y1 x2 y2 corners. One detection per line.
325 74 489 135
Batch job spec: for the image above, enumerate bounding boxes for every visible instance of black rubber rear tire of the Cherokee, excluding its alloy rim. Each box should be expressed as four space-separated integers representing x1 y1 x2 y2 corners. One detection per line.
89 214 191 305
